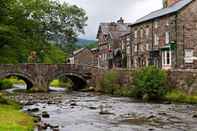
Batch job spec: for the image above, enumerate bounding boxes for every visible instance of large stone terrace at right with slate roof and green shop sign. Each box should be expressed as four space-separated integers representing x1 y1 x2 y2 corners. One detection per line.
130 0 197 69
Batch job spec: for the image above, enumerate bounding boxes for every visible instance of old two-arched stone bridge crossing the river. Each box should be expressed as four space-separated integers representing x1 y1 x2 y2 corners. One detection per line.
0 64 102 92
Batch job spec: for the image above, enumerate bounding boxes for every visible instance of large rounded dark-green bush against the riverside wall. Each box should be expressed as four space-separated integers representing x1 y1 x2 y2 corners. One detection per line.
132 66 168 100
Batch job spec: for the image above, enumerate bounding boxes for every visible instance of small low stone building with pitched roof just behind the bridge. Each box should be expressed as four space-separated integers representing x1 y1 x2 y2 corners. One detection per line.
69 48 97 66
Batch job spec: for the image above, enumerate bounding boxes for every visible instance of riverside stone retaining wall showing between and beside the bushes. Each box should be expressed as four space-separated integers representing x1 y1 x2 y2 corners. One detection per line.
97 69 197 94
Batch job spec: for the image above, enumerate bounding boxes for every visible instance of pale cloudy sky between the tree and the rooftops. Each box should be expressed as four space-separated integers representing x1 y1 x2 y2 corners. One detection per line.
62 0 162 40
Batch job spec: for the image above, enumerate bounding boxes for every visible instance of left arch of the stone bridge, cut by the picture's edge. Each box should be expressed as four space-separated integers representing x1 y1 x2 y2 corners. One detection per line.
0 72 33 90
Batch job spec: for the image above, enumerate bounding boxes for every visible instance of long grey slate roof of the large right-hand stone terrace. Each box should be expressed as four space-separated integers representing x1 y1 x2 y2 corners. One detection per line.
131 0 193 26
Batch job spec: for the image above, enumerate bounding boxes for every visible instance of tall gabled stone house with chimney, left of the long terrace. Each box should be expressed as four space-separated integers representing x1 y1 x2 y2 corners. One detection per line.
97 18 129 68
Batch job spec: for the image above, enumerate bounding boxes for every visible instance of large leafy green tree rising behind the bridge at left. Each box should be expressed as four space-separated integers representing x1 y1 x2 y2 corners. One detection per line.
0 0 87 63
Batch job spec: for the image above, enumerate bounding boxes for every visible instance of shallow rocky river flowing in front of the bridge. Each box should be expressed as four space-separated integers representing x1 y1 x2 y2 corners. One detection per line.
5 84 197 131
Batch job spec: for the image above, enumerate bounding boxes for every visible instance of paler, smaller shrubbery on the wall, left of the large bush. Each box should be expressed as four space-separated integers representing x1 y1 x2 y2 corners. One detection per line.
100 70 131 96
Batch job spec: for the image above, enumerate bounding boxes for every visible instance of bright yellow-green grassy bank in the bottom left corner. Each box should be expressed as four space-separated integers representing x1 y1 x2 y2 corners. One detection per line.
0 94 34 131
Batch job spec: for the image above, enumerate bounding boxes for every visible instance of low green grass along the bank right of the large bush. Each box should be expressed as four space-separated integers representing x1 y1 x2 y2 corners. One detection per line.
165 89 197 104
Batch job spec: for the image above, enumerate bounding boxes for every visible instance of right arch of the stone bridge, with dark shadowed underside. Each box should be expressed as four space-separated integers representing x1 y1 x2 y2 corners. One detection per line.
48 72 88 90
